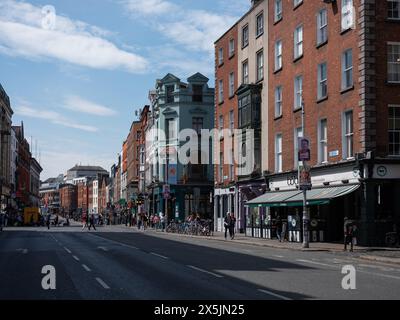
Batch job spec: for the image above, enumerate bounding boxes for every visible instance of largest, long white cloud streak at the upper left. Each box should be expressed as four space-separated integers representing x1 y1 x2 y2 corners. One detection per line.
0 0 148 73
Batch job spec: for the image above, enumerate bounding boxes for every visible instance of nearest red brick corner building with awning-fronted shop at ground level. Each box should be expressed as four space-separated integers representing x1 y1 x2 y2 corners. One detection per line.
216 0 400 245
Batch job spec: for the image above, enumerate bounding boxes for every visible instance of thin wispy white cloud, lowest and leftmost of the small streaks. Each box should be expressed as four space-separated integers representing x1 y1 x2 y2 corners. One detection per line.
15 106 98 132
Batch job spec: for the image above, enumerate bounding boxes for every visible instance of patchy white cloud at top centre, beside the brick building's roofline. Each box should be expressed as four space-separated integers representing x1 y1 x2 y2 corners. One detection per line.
121 0 238 55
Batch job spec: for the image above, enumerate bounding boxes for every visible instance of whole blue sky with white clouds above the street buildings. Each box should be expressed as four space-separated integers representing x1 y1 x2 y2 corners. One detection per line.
0 0 250 180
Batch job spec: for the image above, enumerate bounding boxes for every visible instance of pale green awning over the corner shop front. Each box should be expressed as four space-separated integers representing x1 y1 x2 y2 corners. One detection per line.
246 184 360 207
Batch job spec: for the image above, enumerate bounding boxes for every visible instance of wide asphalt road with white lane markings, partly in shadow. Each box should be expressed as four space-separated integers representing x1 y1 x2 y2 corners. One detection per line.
0 227 400 300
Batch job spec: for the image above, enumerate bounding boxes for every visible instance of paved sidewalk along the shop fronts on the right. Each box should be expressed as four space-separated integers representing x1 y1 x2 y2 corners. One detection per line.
112 222 400 264
